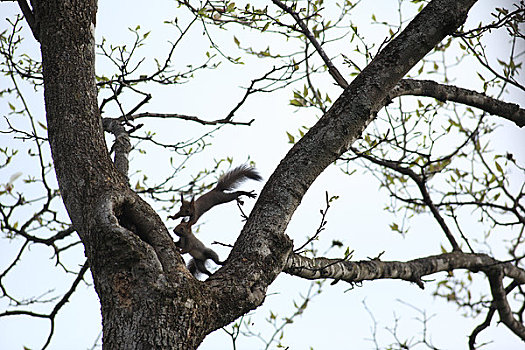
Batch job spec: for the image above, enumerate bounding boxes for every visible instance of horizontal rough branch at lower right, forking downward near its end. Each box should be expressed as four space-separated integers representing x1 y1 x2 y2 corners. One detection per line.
283 252 525 342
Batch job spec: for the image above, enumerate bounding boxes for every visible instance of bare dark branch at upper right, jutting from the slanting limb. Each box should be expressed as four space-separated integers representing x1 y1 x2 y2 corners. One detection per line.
388 79 525 127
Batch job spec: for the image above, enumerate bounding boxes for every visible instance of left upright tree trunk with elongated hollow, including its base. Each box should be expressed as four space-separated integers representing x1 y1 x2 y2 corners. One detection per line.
34 1 207 349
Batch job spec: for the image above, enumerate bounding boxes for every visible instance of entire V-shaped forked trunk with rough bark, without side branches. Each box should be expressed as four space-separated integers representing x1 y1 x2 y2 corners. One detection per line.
34 0 475 349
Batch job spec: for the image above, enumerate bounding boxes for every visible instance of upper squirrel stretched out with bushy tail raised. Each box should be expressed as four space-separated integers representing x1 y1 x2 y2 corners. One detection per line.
168 164 262 226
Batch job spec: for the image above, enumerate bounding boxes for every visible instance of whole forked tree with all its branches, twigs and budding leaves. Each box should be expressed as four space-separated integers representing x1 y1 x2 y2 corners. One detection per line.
0 0 525 349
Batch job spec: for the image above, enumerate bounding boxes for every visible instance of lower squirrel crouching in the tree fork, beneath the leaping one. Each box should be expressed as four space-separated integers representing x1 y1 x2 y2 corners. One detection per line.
173 221 224 277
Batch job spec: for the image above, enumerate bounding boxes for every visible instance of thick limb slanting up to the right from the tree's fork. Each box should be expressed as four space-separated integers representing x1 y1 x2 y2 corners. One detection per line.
206 0 476 329
